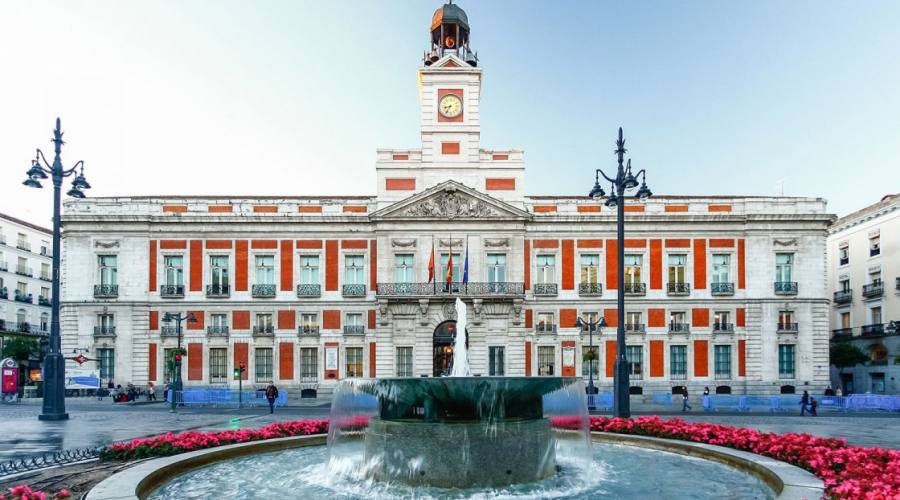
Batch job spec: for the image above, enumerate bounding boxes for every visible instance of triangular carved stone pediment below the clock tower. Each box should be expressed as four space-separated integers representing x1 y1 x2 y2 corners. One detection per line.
372 181 531 220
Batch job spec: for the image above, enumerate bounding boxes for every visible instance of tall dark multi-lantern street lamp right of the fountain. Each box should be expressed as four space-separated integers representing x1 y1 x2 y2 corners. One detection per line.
588 127 653 417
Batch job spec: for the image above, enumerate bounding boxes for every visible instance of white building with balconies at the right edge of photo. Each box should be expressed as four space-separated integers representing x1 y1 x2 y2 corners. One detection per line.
828 194 900 394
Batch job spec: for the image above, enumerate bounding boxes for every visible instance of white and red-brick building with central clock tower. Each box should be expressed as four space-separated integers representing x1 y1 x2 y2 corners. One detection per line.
62 1 833 393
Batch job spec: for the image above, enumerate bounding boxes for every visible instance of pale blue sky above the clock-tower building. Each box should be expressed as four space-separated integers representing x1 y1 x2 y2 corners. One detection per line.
0 0 900 223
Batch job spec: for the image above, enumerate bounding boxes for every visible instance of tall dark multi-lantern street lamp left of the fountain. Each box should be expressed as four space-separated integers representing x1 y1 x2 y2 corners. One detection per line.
22 118 91 420
